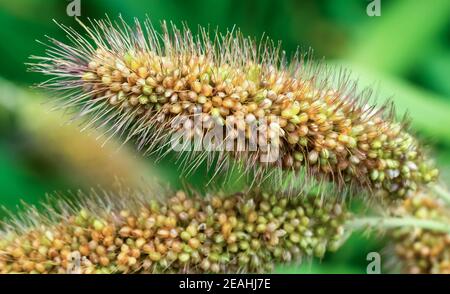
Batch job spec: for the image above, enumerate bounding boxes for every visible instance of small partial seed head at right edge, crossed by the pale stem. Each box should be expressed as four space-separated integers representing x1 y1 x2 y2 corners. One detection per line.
392 194 450 274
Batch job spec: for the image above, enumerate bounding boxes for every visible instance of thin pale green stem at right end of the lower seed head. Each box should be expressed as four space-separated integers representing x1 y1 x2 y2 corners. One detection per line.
347 217 450 234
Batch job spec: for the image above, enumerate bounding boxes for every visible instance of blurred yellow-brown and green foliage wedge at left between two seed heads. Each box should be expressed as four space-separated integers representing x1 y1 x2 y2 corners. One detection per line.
0 79 158 212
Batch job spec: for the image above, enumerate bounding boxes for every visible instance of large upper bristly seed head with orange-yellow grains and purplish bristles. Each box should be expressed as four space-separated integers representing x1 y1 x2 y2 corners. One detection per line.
32 17 437 198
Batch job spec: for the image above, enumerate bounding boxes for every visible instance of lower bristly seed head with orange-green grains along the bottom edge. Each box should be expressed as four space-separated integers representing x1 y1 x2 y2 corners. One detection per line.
0 191 349 273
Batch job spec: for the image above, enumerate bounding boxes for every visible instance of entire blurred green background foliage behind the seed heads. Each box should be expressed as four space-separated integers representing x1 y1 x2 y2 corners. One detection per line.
0 0 450 273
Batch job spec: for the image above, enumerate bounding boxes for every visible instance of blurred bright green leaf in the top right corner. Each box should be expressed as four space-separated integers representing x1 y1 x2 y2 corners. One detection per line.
347 0 450 73
